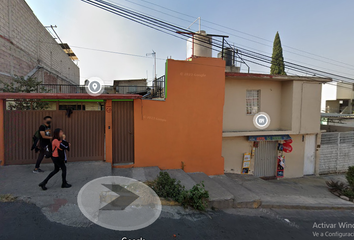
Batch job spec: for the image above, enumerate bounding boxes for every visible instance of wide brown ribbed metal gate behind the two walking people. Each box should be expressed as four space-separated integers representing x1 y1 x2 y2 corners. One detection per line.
5 107 105 165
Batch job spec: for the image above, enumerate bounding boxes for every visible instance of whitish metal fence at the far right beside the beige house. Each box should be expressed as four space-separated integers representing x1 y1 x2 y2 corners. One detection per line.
320 132 354 174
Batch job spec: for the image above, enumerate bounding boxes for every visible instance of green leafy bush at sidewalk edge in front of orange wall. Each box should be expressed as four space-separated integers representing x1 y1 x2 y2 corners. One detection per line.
149 172 209 211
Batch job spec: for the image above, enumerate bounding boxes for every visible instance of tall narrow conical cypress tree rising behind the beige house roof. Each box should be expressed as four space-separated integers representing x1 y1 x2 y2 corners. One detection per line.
270 32 286 75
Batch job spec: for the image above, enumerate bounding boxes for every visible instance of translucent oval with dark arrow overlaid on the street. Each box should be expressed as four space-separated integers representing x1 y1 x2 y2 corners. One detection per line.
77 176 162 231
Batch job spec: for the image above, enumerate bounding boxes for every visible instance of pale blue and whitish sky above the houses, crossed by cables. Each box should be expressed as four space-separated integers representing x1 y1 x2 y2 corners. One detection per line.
26 0 354 108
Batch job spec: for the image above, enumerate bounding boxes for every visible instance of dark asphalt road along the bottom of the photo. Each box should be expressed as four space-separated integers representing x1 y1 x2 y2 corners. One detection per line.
0 202 354 240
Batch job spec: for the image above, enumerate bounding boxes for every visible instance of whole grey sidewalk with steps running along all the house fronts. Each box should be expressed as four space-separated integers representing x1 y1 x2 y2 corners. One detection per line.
0 161 354 231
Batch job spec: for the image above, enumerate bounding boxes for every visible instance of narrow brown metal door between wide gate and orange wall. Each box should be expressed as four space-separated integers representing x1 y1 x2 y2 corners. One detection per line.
112 101 134 164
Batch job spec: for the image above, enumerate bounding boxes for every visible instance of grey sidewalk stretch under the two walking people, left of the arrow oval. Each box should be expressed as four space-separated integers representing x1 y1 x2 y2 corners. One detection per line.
0 162 112 227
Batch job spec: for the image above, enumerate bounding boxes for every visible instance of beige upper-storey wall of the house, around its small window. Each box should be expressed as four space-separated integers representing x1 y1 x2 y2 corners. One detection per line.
223 77 321 134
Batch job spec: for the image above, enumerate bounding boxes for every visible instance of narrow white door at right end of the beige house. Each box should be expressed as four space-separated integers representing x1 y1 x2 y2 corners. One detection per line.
304 135 316 175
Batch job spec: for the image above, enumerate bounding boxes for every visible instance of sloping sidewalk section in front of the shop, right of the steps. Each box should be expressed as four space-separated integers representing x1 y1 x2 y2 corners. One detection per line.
225 174 354 209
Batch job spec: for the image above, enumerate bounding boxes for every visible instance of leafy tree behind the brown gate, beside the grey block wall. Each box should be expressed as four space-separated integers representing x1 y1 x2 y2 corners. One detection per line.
0 76 50 110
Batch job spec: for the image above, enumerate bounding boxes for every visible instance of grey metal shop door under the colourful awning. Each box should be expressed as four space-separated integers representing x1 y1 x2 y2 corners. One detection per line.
254 141 278 177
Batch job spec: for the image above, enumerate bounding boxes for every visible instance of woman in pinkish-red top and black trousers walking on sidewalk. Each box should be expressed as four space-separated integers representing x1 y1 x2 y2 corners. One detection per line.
39 128 71 190
